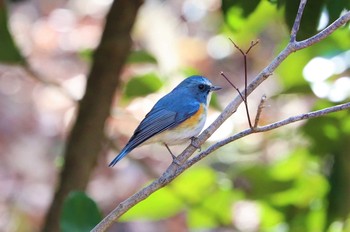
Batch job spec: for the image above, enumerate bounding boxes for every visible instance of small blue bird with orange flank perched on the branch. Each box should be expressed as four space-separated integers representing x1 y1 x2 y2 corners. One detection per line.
109 76 221 167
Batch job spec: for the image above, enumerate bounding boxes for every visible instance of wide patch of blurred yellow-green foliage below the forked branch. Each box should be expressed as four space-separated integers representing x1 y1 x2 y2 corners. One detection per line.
117 149 329 231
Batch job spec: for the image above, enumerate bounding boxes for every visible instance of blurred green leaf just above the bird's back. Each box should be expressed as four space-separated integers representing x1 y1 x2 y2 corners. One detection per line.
125 73 163 98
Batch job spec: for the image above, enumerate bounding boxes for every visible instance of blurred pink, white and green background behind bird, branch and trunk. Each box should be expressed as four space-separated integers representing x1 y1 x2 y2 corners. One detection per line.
0 0 350 232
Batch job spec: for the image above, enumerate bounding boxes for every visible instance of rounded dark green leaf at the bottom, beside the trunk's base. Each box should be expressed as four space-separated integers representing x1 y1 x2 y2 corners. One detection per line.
60 192 102 232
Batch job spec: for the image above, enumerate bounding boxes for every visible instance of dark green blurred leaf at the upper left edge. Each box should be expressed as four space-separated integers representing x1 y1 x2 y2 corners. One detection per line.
0 1 25 64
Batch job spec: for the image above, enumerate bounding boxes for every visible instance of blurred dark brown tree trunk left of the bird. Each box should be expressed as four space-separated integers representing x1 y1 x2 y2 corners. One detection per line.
42 0 143 232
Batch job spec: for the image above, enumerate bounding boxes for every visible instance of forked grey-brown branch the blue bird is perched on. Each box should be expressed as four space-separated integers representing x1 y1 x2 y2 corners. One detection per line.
92 0 350 232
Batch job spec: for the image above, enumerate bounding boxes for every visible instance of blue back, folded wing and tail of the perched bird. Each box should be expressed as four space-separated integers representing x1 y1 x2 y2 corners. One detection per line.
109 101 199 166
